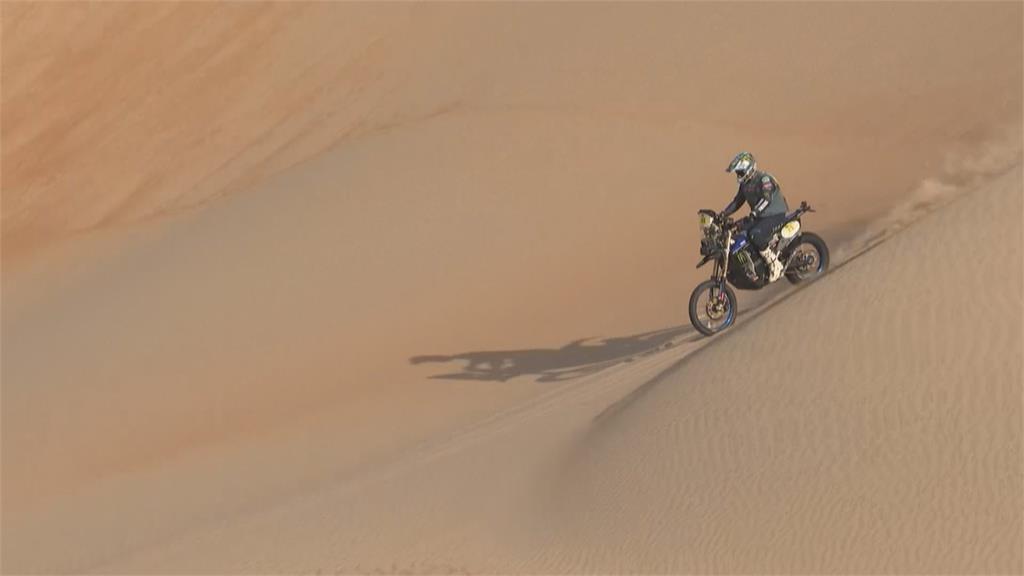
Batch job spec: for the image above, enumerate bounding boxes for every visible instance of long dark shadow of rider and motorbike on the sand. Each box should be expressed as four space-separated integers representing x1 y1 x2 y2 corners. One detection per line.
409 326 701 382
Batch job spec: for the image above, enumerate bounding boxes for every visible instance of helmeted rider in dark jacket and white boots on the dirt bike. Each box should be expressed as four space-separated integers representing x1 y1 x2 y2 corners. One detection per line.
720 152 790 282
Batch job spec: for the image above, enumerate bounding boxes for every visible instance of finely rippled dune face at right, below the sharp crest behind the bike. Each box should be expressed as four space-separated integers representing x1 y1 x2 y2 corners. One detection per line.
552 163 1024 573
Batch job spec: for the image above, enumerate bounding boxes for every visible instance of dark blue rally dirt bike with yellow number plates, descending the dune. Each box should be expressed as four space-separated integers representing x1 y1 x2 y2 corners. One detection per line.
690 202 828 336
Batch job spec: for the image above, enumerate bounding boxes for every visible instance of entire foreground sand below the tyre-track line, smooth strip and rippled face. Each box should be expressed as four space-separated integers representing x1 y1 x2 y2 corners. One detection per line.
92 163 1024 574
